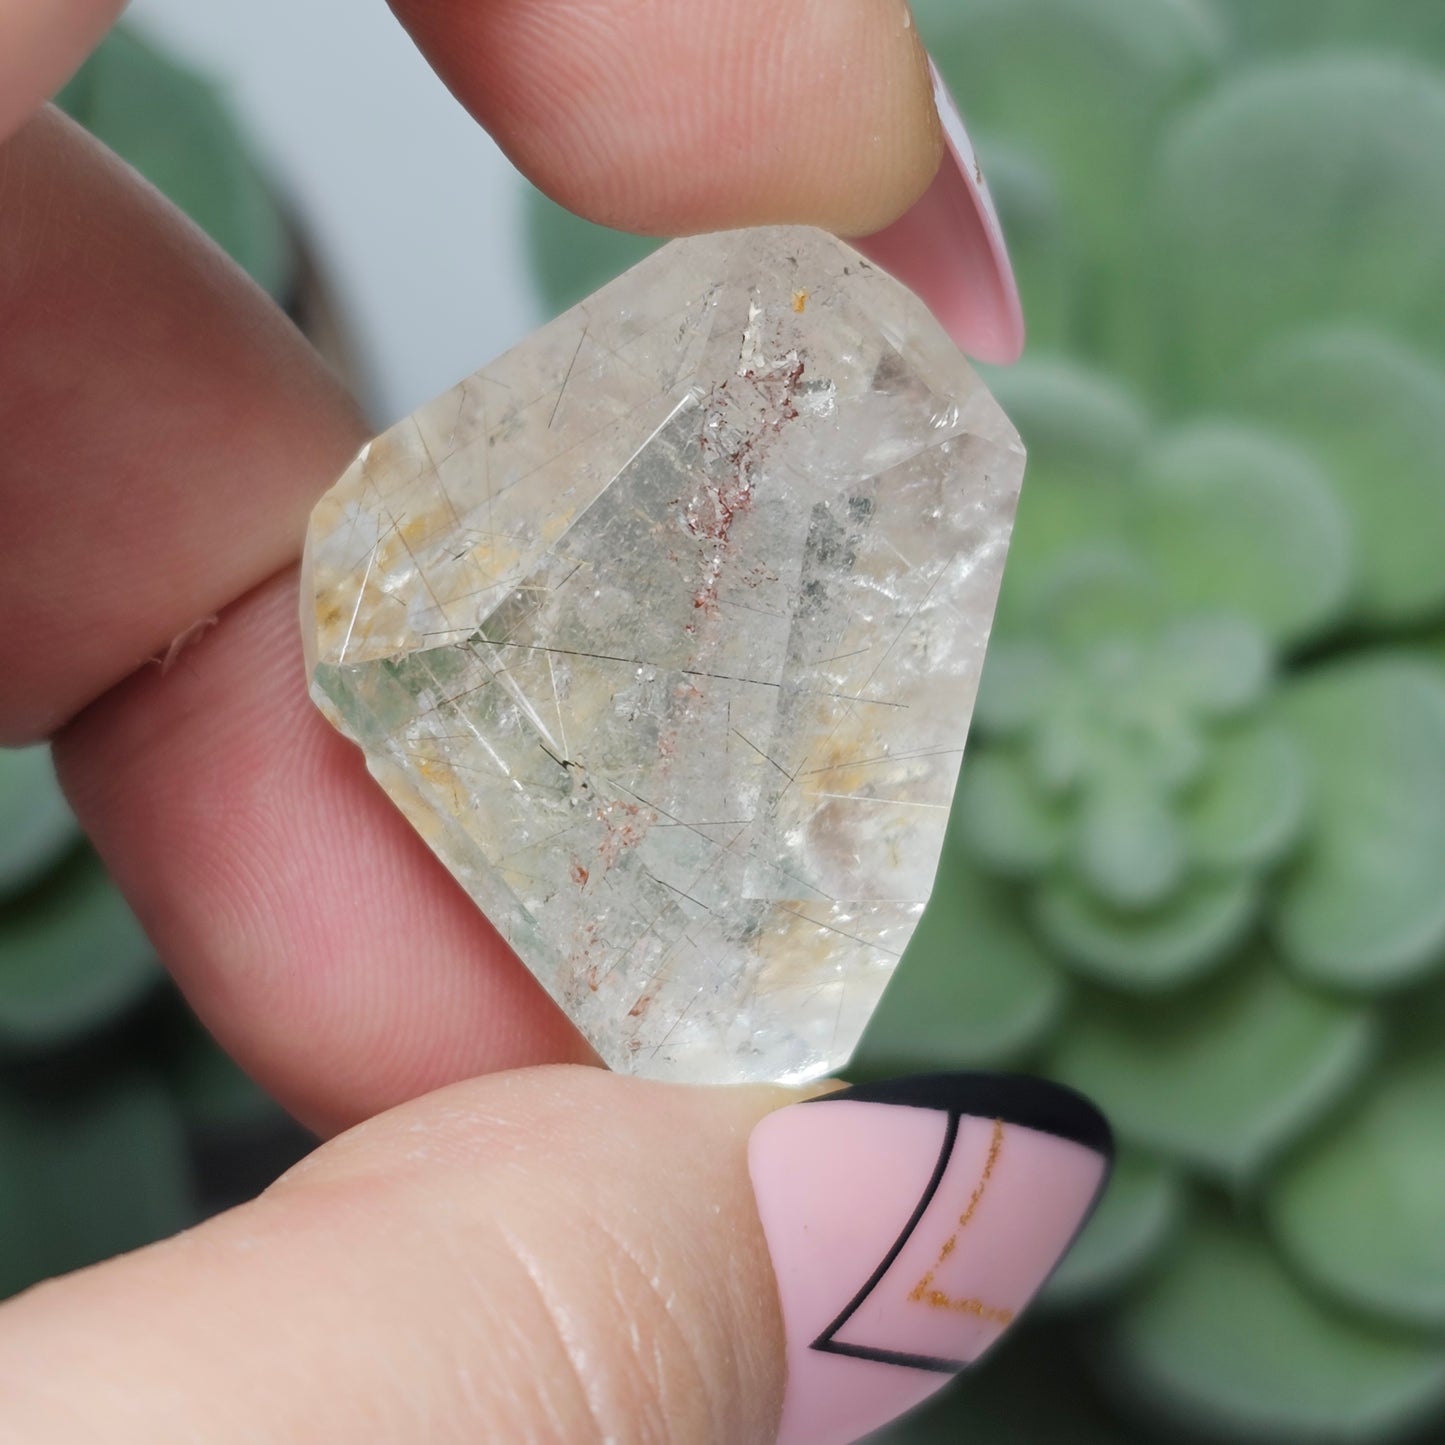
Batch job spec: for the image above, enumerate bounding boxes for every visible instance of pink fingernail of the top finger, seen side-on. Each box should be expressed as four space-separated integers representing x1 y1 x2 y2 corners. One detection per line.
854 61 1023 366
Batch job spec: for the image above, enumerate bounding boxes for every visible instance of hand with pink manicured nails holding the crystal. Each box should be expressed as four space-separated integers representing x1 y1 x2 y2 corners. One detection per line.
0 0 1105 1445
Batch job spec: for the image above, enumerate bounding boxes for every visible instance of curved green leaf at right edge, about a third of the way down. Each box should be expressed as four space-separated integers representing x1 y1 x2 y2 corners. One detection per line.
1237 332 1445 623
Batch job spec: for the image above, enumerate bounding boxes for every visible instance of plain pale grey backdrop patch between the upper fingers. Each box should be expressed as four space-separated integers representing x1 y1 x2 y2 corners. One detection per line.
129 0 542 422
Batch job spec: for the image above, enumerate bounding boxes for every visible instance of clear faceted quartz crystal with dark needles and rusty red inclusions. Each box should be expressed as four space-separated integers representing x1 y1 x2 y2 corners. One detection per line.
302 227 1023 1082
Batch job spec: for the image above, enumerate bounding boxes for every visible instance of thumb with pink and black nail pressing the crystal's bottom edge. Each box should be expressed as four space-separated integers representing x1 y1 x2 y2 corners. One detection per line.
0 1068 1108 1445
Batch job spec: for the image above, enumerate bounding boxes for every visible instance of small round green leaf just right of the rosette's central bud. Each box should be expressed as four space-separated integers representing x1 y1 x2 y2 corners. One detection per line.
1182 723 1309 870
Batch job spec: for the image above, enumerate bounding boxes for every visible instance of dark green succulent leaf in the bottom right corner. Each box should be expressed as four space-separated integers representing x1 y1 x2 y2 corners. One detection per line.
1103 1212 1445 1445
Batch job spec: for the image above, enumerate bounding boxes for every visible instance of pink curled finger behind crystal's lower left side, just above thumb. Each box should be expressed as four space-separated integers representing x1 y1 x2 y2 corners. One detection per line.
55 569 592 1134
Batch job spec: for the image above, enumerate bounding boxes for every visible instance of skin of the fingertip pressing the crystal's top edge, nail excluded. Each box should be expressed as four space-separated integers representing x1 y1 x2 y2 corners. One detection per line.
393 0 942 236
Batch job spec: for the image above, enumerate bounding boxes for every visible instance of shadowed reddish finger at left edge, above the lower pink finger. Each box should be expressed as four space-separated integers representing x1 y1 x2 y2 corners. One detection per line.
0 109 364 743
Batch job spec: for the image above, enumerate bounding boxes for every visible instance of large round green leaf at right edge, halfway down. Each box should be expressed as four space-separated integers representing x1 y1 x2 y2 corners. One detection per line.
1273 655 1445 990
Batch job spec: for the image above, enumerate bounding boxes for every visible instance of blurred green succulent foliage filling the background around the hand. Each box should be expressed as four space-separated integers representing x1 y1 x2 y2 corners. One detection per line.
8 0 1445 1445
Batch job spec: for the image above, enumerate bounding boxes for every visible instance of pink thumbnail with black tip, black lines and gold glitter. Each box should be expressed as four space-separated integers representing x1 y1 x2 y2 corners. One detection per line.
749 1074 1113 1445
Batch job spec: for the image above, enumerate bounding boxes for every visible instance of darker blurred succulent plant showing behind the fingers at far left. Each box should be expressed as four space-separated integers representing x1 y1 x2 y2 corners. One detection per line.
0 30 299 1299
